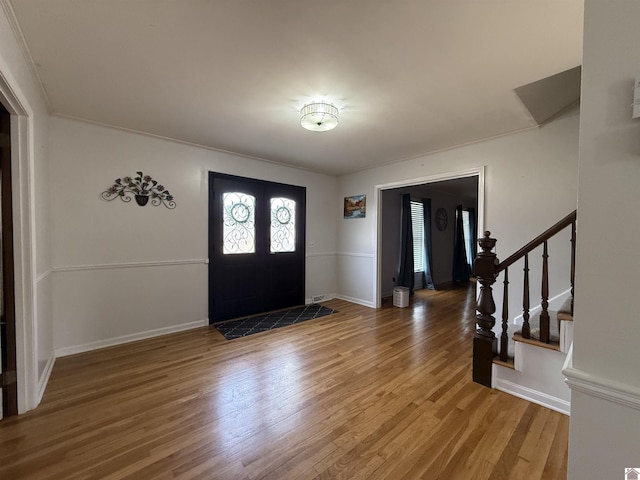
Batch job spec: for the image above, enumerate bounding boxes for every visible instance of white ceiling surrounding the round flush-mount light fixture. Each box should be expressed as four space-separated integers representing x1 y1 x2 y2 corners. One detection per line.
5 0 583 175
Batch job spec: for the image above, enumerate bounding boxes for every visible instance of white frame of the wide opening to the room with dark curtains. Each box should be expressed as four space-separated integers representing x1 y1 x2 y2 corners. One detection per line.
373 166 486 308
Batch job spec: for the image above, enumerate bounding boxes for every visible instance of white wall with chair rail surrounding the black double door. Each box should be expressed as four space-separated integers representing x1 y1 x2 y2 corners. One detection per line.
50 117 340 355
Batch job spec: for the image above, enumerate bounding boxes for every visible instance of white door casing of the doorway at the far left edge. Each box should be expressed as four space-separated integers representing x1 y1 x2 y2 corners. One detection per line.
0 63 37 413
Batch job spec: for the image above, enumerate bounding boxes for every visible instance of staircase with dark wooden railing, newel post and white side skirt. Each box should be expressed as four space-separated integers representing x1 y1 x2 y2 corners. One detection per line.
473 211 577 414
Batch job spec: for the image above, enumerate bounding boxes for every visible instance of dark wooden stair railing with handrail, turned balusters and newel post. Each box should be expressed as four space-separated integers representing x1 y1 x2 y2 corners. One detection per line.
473 210 578 387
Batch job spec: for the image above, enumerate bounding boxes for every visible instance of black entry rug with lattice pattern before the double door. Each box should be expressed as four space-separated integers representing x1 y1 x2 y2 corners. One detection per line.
214 303 337 340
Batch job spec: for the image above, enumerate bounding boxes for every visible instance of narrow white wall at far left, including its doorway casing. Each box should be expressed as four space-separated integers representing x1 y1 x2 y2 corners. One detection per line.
0 1 54 412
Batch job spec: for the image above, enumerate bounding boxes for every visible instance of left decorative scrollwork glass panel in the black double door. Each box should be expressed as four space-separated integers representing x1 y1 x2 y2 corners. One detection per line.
222 192 256 255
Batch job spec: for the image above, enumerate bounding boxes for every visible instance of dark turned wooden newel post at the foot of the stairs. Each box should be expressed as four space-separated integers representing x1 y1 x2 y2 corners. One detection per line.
473 231 498 387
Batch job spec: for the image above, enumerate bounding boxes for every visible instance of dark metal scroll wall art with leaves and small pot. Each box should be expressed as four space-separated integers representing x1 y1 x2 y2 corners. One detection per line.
100 172 176 209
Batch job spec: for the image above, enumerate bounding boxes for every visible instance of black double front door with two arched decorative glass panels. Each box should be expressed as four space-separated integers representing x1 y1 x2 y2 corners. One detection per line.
209 172 306 323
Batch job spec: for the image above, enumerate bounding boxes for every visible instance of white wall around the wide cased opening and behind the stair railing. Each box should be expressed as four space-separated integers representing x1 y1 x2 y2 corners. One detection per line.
338 110 579 315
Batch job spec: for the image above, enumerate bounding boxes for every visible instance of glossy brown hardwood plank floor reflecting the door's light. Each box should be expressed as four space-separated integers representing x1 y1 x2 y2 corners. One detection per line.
0 289 569 480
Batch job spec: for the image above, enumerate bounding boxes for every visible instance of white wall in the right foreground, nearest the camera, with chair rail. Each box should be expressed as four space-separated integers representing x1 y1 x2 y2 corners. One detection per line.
567 0 640 479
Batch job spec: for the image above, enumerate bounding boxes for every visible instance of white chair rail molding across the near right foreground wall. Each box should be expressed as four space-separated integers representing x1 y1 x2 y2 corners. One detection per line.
562 345 640 410
